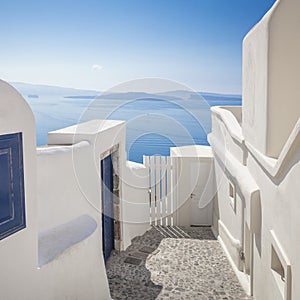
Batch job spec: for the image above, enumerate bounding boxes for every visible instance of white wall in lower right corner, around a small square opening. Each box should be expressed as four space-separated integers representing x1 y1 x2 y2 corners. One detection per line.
248 138 300 300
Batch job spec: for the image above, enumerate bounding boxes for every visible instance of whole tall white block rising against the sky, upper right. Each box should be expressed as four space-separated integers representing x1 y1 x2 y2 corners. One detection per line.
243 0 300 158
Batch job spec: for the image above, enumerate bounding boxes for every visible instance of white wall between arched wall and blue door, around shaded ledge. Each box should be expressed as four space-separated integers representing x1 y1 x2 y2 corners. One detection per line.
37 142 110 300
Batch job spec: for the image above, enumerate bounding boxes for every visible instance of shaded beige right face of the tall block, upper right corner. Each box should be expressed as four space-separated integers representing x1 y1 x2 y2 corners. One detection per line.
267 0 300 157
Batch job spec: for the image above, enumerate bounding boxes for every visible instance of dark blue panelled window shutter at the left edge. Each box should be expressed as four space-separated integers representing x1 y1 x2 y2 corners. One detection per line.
0 133 26 240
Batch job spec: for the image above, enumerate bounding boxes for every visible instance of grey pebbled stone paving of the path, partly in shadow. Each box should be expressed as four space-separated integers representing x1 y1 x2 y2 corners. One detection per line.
106 227 251 300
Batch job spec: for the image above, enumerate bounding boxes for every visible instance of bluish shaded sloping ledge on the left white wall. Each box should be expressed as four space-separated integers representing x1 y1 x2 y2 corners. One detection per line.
38 215 97 267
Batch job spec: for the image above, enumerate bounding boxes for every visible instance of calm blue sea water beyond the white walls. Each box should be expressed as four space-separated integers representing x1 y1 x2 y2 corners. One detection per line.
24 94 241 162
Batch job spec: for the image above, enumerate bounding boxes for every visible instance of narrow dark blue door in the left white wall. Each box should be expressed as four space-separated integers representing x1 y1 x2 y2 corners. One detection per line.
101 155 114 261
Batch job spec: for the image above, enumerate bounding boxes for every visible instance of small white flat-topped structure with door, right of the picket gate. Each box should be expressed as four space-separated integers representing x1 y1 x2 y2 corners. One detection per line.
170 145 216 226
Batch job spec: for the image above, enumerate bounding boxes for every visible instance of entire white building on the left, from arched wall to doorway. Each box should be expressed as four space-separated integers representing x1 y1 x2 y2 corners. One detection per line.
0 81 134 300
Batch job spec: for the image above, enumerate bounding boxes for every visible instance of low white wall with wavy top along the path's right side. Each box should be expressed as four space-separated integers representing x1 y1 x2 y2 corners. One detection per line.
209 107 261 293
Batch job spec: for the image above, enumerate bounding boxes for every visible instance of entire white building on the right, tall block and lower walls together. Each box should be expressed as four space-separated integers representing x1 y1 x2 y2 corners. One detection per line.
209 0 300 300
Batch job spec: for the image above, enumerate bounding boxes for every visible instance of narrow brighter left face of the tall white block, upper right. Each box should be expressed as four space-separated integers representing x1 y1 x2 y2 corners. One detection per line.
242 8 269 153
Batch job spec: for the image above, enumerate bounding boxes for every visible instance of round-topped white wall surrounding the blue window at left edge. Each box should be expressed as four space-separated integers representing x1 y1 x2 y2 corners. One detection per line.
0 81 38 300
